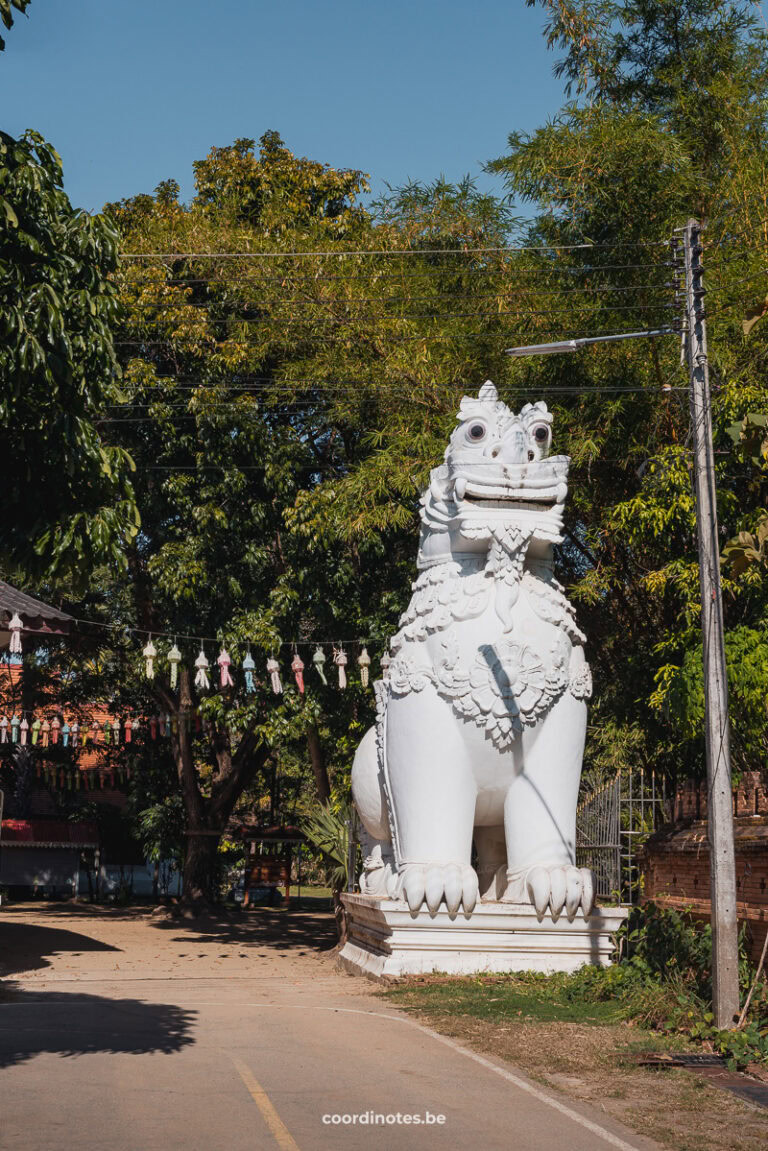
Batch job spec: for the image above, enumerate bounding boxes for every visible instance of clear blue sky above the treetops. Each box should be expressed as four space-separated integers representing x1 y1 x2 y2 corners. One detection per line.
0 0 562 211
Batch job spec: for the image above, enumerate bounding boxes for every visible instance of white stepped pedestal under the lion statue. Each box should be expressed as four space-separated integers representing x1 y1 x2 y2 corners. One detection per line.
340 894 626 978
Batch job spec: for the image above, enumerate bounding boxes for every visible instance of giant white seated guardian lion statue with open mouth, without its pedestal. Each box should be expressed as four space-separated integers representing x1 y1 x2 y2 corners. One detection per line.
352 381 594 921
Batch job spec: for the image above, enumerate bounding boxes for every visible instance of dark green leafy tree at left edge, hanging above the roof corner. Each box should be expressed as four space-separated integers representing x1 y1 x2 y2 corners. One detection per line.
0 131 138 586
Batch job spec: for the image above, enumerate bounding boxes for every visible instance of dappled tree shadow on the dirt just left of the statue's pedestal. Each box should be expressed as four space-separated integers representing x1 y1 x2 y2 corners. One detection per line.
151 907 339 953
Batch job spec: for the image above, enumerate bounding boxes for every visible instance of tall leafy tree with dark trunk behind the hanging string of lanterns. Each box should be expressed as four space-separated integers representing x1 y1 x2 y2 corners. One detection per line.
88 134 393 901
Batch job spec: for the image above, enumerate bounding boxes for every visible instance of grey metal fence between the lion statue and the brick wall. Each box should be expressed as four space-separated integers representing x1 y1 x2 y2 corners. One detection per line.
576 771 670 904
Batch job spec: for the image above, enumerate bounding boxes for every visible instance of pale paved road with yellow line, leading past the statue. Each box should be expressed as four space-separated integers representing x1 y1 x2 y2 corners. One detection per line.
0 915 652 1151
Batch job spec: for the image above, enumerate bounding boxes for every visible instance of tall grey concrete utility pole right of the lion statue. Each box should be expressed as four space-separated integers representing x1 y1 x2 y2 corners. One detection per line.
683 220 739 1028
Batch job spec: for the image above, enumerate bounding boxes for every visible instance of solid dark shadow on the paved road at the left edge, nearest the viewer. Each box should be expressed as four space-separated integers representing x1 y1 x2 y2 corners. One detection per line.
0 983 197 1068
